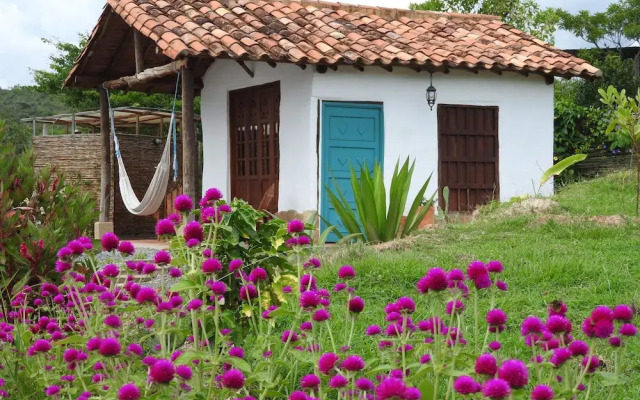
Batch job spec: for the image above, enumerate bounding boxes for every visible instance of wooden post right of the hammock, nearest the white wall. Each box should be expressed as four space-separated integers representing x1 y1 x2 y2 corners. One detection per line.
181 60 198 201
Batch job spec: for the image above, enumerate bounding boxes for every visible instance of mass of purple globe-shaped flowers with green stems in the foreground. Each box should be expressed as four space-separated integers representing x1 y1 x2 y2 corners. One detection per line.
0 191 637 400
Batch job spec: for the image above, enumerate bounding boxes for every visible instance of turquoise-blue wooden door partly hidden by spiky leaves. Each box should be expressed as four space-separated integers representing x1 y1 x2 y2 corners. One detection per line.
320 101 384 242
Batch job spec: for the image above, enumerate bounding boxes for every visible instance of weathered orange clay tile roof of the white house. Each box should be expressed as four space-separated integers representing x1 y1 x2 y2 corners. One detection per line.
94 0 601 78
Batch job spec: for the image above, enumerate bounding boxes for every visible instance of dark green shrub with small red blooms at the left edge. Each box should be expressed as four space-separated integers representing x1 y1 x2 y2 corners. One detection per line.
0 123 96 283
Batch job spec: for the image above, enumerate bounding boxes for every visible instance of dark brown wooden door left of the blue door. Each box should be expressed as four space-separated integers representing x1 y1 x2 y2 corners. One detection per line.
229 82 280 213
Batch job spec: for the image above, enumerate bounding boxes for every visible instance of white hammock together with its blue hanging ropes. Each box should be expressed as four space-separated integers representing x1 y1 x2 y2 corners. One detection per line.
107 73 180 215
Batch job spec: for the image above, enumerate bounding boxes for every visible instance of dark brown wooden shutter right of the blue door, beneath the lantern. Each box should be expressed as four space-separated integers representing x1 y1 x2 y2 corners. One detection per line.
438 104 500 212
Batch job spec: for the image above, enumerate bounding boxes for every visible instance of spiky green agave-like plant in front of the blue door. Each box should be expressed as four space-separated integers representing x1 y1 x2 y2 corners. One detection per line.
325 157 435 242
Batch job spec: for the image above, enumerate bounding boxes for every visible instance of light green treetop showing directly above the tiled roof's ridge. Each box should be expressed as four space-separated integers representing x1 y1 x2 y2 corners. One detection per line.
410 0 559 43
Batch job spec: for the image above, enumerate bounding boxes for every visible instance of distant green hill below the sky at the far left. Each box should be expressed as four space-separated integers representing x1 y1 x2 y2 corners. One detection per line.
0 86 68 122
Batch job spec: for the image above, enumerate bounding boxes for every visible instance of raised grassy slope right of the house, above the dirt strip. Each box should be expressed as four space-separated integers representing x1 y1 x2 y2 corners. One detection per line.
555 171 636 216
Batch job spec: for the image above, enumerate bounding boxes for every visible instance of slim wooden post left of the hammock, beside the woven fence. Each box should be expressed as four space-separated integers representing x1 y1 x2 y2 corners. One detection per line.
99 88 111 222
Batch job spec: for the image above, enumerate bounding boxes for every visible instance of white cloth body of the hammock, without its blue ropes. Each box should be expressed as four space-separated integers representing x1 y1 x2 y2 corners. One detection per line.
111 114 175 215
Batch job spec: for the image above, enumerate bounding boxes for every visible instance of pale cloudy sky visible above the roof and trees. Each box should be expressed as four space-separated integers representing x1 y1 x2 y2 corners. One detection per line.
0 0 613 88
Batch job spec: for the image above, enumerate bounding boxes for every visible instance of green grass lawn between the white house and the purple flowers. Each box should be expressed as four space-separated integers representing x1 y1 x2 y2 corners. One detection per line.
319 173 640 399
